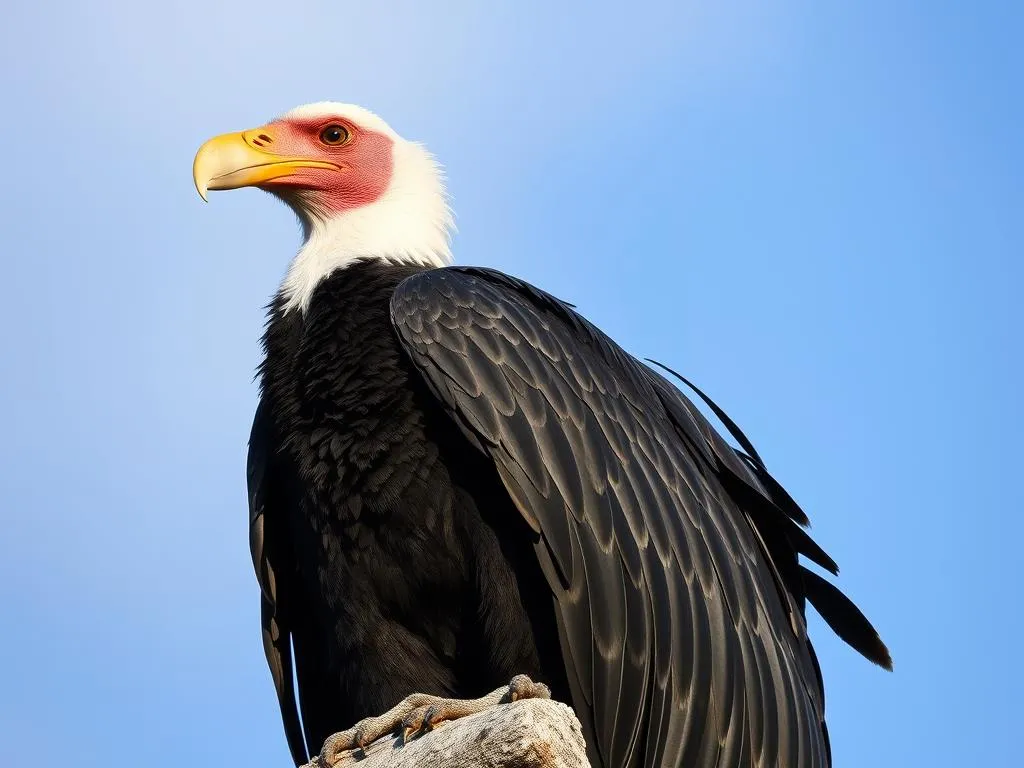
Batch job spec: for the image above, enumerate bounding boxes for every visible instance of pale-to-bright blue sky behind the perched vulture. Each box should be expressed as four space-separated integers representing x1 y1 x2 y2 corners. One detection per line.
0 0 1024 768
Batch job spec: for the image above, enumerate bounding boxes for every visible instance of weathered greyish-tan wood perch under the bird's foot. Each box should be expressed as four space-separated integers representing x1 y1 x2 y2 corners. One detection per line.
309 698 590 768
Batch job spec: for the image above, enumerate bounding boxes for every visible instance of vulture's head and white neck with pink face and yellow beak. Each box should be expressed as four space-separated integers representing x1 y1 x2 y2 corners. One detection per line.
193 101 454 309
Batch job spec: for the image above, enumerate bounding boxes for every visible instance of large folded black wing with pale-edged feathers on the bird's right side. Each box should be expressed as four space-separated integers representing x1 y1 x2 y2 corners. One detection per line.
391 268 888 768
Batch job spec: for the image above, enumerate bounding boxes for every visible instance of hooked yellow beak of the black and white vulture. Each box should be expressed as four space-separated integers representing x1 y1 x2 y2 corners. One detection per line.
193 128 339 200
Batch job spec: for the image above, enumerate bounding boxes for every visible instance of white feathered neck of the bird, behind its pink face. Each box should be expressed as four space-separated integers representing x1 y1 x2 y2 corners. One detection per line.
281 141 455 312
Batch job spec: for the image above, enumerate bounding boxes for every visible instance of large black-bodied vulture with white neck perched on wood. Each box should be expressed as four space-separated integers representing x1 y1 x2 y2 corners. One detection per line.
193 101 892 768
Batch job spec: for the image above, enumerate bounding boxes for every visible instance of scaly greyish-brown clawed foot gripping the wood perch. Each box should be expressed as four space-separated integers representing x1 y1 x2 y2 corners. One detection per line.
312 675 551 768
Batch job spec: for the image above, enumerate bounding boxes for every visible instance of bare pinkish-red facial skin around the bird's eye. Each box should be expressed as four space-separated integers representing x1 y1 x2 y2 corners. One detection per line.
256 117 393 213
